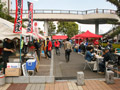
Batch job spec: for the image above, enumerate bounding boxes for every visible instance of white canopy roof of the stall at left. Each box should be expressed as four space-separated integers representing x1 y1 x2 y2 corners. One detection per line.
0 18 37 40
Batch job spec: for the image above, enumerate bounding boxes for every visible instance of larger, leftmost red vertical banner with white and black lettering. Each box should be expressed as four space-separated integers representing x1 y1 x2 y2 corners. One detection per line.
13 0 23 33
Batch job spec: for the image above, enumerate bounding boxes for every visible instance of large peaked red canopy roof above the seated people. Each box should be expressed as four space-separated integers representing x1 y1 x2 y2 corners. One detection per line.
76 30 102 38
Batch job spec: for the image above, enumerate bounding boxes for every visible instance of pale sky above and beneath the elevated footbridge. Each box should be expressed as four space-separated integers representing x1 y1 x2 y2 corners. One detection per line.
11 0 116 34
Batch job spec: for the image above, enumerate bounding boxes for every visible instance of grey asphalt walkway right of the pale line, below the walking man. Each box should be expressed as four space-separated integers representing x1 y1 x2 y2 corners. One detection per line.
54 49 104 79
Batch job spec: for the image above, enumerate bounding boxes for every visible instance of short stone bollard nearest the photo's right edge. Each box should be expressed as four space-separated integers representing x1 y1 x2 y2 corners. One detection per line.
105 71 115 84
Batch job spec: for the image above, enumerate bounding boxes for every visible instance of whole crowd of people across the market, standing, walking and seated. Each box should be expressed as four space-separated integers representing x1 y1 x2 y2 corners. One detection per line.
0 38 120 74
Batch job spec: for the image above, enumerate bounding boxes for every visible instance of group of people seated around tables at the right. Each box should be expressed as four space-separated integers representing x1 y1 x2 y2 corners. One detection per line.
74 40 120 74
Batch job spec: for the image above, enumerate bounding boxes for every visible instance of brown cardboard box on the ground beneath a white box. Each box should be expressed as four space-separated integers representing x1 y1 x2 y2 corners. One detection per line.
5 68 21 76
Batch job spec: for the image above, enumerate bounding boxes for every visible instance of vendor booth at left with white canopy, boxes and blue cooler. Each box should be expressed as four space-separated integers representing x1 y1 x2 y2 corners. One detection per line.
0 18 45 76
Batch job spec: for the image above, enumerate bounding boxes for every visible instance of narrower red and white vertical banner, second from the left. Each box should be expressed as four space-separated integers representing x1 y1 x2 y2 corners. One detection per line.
27 2 33 33
